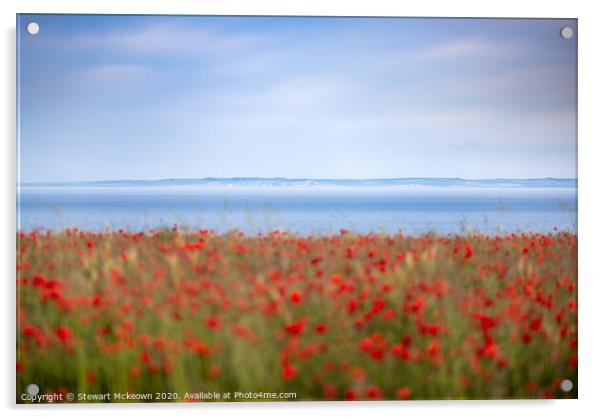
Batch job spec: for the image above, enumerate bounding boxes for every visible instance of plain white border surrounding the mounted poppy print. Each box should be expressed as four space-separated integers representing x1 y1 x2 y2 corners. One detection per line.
0 0 602 418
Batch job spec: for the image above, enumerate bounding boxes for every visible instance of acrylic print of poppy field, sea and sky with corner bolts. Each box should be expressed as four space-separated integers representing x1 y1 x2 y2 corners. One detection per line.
16 14 578 403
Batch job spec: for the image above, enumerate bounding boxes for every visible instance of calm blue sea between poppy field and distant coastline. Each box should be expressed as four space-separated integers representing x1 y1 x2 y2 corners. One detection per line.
17 187 577 234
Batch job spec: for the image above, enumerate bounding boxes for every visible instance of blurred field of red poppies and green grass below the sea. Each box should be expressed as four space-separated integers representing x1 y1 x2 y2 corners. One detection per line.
16 227 578 402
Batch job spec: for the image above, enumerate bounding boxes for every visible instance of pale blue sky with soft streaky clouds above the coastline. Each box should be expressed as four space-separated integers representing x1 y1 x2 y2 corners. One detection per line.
17 15 577 182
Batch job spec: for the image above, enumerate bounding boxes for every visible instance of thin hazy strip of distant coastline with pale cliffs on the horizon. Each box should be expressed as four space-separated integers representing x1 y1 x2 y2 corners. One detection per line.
19 177 577 188
